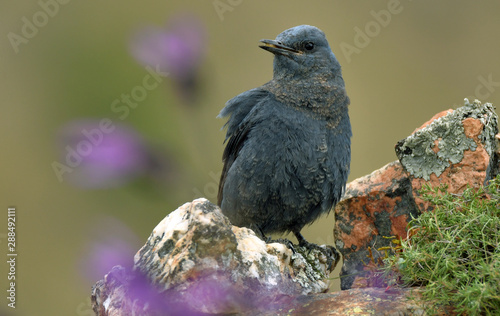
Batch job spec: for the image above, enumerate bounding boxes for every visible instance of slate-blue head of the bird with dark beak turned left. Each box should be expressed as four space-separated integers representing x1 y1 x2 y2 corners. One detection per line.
260 25 343 83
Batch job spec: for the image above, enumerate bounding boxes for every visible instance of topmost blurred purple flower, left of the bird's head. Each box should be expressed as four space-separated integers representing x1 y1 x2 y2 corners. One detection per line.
130 13 206 102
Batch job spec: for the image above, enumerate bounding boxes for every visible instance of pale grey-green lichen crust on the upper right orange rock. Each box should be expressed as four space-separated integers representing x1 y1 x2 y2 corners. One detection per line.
396 99 498 180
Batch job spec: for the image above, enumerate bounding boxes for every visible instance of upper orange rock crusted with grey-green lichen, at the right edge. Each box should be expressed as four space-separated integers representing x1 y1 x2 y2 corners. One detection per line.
396 100 498 210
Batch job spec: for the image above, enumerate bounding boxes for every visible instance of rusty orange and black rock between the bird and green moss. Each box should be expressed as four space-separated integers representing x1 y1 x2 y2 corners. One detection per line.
334 161 418 289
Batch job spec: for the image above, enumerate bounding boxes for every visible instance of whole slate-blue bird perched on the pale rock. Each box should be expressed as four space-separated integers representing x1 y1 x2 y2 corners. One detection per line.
218 25 352 251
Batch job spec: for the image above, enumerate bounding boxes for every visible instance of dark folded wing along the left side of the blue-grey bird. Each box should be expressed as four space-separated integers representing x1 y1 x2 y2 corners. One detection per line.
218 88 269 205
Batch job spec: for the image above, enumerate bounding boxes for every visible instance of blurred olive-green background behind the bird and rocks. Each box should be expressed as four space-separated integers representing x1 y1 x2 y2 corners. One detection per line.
0 0 500 316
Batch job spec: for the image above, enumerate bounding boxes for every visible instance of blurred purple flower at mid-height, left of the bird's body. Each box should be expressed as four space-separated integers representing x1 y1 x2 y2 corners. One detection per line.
60 119 158 189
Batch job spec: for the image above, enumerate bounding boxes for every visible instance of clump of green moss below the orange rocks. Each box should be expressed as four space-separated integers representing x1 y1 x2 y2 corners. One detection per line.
385 176 500 315
